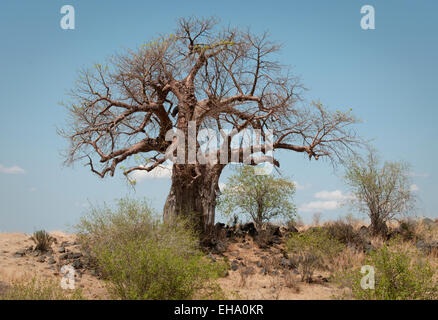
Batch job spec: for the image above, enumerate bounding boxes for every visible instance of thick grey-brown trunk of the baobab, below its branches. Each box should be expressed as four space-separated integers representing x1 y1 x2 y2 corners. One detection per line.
163 164 222 235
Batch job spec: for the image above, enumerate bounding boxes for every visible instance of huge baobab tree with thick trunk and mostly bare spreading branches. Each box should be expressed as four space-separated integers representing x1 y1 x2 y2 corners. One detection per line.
60 17 359 232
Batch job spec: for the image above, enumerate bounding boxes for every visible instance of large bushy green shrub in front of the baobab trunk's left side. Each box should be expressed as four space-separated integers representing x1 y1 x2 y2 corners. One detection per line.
78 199 226 299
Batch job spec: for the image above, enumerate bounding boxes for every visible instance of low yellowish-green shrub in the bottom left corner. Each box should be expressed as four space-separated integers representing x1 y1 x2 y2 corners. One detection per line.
0 277 84 300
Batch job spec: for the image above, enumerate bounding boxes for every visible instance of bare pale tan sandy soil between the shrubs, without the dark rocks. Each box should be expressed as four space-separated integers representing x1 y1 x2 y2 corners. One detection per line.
0 232 340 300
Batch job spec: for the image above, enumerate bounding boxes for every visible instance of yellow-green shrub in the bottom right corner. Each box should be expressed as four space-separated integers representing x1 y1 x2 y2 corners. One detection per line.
344 240 438 300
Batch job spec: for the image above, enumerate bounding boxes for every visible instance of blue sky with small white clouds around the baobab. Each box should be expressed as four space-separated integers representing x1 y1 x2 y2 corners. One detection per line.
0 0 438 232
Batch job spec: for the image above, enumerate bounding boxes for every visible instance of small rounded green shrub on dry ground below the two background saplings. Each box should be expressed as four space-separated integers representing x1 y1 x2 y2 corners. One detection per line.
287 228 344 282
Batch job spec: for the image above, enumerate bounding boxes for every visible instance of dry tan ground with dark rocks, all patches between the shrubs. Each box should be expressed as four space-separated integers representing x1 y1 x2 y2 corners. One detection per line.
0 219 438 300
